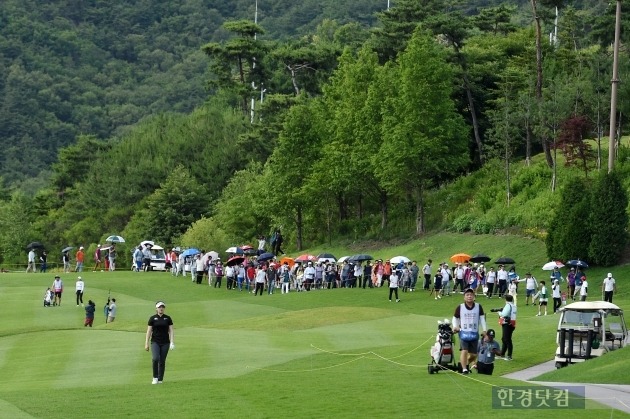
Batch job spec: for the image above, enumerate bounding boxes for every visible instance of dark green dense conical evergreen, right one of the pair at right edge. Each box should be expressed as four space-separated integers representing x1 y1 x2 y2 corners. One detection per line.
588 171 628 266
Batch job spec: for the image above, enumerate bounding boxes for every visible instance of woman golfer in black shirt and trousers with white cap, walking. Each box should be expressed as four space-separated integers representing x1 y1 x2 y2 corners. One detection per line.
144 301 175 384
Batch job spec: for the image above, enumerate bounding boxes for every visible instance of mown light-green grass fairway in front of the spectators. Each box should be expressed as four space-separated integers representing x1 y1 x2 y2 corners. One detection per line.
0 264 627 418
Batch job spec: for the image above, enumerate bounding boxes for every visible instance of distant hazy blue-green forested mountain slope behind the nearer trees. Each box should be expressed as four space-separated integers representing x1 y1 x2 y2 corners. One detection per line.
0 0 382 186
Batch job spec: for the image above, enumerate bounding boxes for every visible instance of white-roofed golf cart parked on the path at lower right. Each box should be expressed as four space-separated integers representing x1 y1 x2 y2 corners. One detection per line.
555 301 628 368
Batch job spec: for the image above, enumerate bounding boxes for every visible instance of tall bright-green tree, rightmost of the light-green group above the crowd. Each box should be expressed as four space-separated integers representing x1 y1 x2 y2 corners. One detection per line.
376 30 468 233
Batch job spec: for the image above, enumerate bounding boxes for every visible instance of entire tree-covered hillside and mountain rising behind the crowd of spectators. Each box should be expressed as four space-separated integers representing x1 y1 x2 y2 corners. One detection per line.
0 0 630 268
